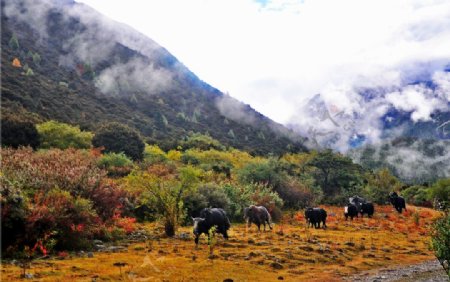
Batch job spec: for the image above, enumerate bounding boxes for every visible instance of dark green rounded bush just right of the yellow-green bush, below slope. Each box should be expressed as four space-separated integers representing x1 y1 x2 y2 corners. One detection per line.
92 122 145 160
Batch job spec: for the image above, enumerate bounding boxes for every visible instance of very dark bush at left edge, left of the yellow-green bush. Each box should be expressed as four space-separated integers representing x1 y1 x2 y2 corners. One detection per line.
1 117 40 149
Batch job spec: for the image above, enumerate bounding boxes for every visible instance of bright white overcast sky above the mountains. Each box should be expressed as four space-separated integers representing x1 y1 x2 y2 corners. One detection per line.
80 0 450 123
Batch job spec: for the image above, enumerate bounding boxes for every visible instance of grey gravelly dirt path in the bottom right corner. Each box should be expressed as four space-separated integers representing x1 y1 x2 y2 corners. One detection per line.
344 260 449 282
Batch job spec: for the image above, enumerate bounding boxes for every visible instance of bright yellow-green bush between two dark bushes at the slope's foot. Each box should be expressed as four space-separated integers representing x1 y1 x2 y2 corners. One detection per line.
37 120 93 149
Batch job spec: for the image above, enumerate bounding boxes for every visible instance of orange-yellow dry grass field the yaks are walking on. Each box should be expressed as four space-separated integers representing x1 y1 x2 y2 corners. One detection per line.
2 206 439 281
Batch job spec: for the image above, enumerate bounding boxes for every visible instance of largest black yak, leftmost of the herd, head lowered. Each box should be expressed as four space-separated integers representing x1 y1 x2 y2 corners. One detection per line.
192 208 231 245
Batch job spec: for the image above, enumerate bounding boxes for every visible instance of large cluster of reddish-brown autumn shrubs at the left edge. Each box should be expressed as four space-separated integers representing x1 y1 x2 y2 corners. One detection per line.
0 148 134 255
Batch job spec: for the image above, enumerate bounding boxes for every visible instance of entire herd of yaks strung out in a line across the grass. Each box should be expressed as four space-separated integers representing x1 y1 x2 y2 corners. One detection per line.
192 192 406 245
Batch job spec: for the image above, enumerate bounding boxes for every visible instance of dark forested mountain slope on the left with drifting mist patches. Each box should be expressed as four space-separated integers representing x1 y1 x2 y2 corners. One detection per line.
1 0 304 154
